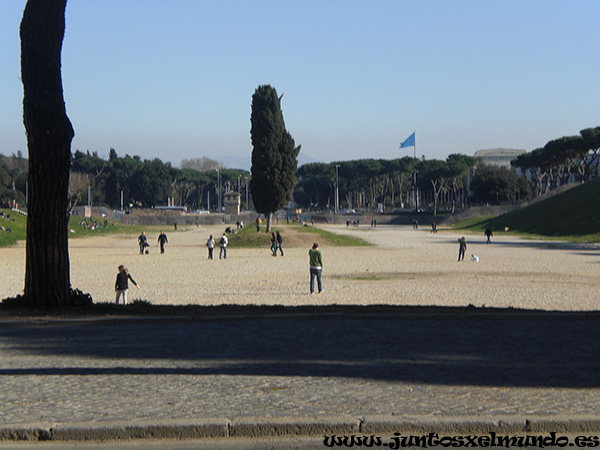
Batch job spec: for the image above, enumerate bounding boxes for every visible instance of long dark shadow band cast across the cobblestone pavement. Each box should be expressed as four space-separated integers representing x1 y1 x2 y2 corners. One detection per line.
0 306 600 388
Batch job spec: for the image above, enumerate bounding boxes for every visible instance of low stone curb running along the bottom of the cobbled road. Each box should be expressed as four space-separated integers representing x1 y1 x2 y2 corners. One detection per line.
0 416 600 442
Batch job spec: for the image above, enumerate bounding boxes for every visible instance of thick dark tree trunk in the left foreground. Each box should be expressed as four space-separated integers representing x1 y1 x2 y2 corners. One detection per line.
21 0 74 307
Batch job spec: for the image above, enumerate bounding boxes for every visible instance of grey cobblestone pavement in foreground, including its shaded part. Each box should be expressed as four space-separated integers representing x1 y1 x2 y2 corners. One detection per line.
0 309 600 440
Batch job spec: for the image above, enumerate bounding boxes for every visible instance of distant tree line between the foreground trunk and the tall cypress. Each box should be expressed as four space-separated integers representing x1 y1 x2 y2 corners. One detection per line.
69 149 250 210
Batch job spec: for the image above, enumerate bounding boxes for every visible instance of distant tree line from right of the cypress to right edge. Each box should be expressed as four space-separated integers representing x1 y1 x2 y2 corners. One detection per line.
294 127 600 214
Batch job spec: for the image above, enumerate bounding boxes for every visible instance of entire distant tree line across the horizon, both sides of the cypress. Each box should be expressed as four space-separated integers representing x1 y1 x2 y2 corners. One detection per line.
5 127 600 216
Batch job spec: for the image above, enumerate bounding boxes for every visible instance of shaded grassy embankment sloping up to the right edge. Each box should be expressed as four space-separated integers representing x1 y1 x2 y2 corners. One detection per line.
452 178 600 242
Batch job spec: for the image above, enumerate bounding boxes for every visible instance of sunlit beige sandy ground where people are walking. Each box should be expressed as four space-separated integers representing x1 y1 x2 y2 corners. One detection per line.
0 225 600 311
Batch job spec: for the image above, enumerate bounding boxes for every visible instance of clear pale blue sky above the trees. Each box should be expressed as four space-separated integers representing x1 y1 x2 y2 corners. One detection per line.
0 0 600 167
